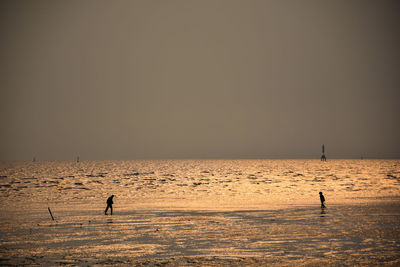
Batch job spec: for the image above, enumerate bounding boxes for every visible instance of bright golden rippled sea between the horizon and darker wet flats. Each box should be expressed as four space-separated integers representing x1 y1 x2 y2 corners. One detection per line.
0 160 400 208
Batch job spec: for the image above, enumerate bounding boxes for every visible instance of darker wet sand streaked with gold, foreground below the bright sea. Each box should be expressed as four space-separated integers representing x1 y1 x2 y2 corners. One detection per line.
0 202 400 266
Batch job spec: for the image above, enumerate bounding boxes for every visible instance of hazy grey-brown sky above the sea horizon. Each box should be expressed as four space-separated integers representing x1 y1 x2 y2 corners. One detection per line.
0 0 400 160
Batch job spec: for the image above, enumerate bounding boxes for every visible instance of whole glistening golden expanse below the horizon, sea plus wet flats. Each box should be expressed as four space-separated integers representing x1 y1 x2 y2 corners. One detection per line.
0 160 400 265
